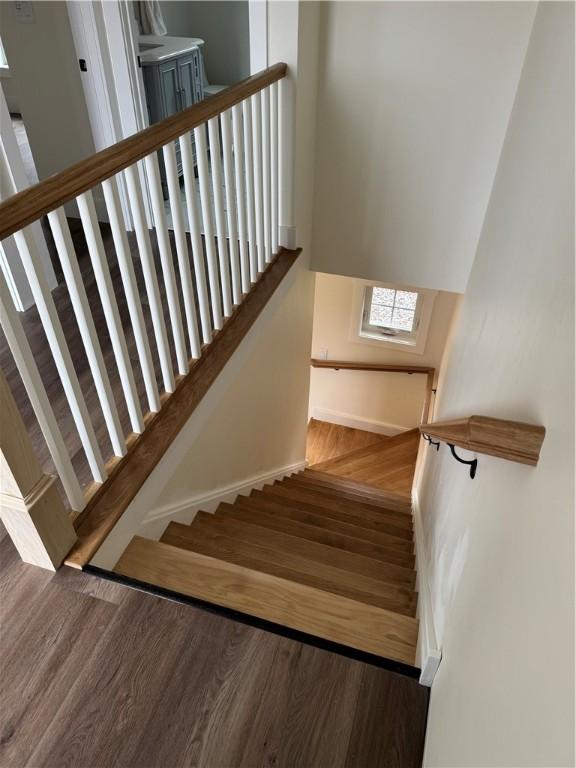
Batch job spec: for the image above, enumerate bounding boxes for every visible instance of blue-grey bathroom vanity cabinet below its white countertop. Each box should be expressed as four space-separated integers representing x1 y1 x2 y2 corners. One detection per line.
142 48 204 198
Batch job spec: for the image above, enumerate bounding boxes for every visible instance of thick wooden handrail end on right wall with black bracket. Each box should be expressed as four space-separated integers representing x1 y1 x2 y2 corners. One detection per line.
419 416 546 466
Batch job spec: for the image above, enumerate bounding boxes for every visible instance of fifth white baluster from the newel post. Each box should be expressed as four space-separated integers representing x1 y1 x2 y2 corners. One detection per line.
102 178 160 413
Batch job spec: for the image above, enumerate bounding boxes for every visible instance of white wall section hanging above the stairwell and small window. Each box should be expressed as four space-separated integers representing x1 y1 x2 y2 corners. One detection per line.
312 2 535 292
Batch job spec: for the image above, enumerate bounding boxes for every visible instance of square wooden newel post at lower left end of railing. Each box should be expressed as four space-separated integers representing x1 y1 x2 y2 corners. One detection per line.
0 371 76 570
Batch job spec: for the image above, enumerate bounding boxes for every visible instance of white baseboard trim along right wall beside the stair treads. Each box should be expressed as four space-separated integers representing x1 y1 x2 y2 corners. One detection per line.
412 489 442 687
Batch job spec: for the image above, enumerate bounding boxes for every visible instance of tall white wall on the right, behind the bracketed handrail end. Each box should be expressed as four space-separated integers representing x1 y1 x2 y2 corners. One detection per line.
418 2 574 768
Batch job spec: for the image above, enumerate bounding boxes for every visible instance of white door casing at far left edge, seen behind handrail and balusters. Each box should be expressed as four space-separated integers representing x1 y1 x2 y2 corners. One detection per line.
0 87 58 312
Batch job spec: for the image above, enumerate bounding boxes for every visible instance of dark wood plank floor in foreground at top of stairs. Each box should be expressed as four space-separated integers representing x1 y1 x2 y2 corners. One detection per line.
0 524 428 768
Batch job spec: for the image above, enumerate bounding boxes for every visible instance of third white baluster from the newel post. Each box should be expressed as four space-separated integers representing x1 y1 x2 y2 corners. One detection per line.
48 208 126 456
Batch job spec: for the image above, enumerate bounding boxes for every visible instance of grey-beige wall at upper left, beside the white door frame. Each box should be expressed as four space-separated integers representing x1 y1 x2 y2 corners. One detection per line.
0 2 94 180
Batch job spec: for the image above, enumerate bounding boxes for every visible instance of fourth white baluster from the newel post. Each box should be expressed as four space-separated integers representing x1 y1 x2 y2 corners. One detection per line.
76 192 144 434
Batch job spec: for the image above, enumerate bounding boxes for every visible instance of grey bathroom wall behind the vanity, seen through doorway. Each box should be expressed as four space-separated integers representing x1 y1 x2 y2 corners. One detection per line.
161 0 250 85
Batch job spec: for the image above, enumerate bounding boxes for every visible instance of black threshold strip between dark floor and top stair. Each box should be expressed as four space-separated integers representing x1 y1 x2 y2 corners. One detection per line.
83 564 420 680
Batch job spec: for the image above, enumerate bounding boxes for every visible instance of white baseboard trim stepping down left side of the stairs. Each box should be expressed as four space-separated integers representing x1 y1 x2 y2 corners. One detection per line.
142 460 306 525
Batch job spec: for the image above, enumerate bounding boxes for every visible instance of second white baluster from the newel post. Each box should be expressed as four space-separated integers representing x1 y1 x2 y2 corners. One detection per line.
14 227 106 483
